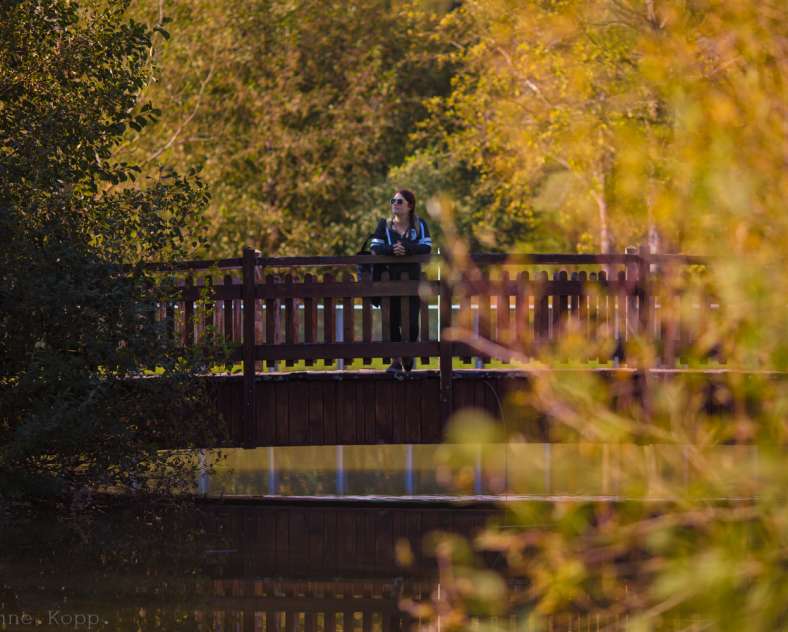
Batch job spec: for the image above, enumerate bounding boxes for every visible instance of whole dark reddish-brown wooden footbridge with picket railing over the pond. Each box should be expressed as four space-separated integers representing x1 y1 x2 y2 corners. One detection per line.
145 249 717 447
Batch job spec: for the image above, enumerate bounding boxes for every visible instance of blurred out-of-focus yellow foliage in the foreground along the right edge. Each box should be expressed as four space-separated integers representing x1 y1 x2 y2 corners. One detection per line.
414 0 788 631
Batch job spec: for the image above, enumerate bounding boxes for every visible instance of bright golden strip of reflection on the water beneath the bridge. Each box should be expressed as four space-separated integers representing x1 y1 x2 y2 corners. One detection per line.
203 443 757 500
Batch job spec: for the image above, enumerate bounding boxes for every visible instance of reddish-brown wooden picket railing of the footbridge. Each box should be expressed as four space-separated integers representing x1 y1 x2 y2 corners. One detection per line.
145 249 716 445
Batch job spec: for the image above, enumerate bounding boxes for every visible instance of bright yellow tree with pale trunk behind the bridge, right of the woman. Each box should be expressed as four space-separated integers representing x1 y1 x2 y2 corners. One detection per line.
422 0 667 252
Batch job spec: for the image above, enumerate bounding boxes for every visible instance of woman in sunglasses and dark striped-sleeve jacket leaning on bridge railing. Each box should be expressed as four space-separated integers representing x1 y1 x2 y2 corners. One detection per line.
370 189 432 373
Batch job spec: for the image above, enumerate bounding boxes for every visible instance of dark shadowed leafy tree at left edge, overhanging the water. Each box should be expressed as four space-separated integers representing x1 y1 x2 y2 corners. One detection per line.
0 0 219 502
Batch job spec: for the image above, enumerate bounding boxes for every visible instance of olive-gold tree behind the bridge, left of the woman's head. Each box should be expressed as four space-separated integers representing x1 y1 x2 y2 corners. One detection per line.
123 0 458 256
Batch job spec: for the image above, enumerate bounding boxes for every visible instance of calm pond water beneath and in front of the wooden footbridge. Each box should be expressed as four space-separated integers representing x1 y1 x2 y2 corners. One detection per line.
0 444 757 632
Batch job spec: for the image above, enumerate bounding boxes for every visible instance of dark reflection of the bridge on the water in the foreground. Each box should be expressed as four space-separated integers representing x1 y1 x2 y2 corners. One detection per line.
0 503 493 632
